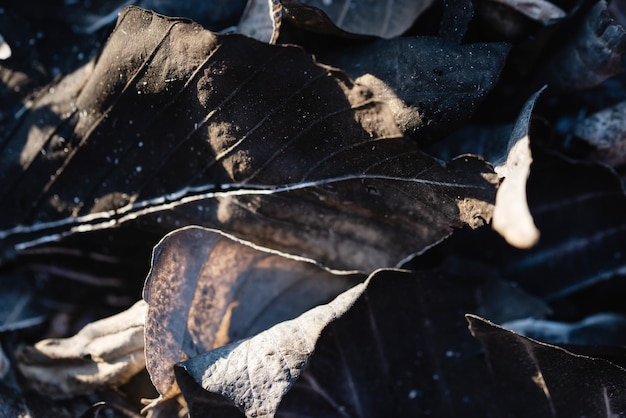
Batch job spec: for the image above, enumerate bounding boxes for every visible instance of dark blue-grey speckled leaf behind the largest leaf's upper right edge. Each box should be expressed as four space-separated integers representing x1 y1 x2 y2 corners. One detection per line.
316 37 509 140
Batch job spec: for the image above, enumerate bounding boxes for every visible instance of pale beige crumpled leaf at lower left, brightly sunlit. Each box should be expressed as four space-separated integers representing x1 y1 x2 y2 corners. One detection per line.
15 301 147 397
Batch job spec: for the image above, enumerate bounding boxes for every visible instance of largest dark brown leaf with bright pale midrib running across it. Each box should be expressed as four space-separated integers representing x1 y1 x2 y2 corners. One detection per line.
0 7 497 271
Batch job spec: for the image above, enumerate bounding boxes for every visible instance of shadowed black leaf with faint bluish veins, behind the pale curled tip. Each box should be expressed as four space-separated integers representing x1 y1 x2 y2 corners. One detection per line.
416 147 626 312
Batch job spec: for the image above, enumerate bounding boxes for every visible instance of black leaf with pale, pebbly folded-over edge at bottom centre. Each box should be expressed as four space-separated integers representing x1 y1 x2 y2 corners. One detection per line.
171 270 552 417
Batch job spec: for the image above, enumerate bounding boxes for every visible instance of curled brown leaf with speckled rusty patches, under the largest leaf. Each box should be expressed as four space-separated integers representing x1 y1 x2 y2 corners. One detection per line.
144 227 364 399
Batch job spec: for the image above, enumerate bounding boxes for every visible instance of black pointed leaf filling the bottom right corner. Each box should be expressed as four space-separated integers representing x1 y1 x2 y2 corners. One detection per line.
467 315 626 417
